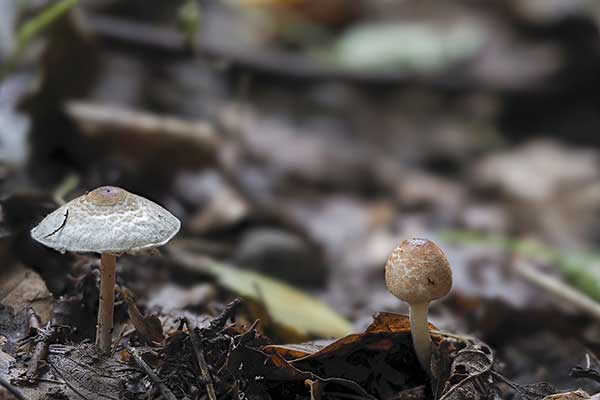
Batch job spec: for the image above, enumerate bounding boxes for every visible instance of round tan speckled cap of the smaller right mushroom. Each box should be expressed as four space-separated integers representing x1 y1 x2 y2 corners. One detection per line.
385 238 452 304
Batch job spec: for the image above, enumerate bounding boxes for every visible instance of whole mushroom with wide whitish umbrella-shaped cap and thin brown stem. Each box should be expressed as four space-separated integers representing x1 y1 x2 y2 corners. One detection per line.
31 186 181 353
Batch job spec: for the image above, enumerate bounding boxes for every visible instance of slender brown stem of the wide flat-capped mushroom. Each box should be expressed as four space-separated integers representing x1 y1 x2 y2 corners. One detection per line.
96 253 117 354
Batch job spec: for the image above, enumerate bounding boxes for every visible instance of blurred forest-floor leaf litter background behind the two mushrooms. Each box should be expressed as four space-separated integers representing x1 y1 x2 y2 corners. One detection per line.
0 0 600 394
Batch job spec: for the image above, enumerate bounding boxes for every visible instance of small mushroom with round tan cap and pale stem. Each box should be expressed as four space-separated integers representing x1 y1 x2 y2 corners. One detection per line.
385 238 452 373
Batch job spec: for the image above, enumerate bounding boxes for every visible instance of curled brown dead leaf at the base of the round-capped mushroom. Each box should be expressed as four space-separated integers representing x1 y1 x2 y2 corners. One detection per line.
262 312 442 399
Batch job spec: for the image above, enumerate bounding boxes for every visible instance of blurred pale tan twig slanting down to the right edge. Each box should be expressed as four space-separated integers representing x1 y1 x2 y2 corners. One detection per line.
514 260 600 320
